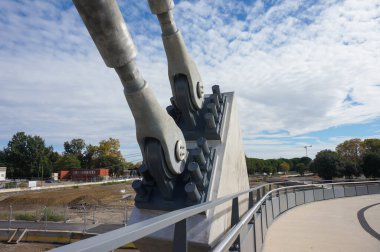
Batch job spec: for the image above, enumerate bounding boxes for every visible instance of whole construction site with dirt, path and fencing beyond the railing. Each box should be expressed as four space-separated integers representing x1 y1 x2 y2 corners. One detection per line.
0 177 264 252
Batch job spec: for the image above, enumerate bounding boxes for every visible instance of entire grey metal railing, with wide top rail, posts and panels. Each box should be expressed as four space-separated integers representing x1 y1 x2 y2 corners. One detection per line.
52 181 380 252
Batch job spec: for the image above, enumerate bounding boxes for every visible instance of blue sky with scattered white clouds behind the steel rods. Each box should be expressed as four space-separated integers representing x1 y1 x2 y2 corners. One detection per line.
0 0 380 161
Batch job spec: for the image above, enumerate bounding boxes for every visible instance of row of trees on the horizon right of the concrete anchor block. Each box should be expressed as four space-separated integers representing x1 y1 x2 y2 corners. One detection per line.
246 138 380 180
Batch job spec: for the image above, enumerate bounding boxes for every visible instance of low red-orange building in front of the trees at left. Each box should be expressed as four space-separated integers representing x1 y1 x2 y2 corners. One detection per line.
59 168 109 181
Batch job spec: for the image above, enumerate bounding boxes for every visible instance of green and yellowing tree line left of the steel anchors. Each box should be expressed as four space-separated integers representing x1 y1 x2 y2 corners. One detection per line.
0 132 134 178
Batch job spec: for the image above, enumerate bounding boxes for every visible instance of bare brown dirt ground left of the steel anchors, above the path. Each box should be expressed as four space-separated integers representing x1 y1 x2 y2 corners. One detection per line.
0 181 135 224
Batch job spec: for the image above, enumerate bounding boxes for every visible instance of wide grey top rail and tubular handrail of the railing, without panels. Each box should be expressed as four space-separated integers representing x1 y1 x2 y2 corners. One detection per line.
51 181 380 252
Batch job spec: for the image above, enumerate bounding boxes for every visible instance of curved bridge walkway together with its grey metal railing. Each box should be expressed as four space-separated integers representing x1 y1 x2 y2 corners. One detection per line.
54 181 380 252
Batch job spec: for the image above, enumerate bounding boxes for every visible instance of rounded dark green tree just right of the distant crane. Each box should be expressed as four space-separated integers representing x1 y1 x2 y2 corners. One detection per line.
314 150 343 180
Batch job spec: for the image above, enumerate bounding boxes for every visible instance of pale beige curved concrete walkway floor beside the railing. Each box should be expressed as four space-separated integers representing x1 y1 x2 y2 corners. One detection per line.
263 194 380 252
